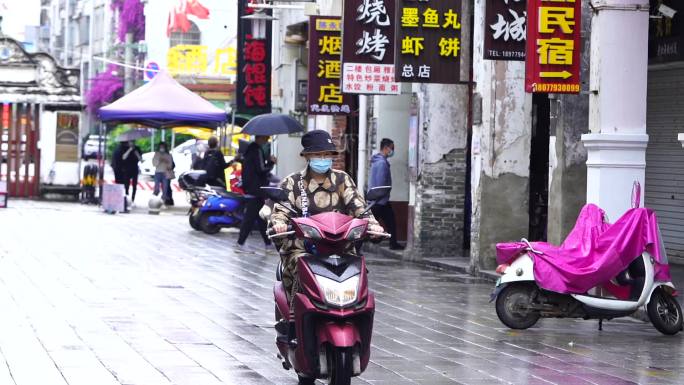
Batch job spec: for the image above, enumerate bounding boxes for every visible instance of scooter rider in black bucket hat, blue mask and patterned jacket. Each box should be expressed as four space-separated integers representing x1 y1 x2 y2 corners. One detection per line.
270 130 384 302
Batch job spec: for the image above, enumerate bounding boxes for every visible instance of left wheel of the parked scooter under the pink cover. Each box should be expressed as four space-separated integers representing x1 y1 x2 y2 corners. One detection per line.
496 283 540 329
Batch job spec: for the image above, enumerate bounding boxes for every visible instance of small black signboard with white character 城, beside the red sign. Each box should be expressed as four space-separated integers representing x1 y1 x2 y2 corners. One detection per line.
483 0 527 60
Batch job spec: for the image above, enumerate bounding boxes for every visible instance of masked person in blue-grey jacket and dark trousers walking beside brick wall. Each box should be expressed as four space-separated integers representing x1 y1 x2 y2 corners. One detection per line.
368 138 404 250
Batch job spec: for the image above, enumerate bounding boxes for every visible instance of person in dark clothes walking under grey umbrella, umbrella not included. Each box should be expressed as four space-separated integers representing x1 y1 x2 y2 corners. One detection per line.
237 136 277 247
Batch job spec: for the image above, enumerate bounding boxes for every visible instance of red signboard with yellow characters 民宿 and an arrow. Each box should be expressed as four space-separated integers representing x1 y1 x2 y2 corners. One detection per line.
525 0 582 94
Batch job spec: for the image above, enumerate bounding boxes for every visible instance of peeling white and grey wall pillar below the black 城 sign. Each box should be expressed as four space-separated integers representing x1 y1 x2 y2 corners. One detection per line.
470 0 532 270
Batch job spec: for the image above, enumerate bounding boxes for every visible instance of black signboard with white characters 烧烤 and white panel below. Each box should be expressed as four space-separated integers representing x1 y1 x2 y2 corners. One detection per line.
342 0 401 95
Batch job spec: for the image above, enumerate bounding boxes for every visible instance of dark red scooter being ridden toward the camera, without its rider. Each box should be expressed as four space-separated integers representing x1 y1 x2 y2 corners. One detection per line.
263 187 389 385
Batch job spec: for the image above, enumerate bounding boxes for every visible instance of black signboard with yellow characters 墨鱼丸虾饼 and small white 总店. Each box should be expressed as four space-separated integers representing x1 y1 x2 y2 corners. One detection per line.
396 0 461 84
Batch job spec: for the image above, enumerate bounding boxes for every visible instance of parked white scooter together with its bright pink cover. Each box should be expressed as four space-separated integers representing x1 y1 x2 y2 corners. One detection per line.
492 205 682 335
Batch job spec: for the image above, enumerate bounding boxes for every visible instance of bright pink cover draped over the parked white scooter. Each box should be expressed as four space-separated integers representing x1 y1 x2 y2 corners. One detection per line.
496 204 670 294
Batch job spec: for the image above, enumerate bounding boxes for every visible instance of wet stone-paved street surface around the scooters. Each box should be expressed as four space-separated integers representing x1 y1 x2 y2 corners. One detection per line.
0 200 684 385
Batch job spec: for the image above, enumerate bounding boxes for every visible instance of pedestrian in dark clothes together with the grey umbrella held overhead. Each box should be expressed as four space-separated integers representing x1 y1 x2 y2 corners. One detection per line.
237 114 304 248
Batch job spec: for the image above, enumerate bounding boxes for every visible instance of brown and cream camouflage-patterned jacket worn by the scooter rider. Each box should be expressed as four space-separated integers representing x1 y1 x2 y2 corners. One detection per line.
270 168 378 255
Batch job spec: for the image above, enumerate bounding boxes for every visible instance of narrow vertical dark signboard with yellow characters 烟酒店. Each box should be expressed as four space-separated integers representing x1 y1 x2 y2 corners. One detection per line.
308 16 353 115
